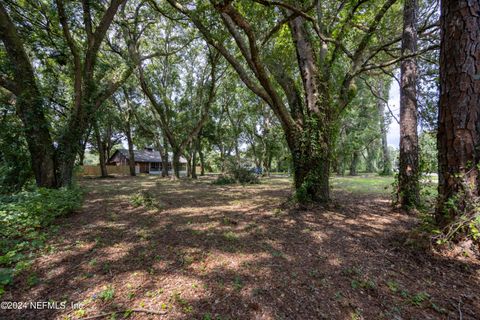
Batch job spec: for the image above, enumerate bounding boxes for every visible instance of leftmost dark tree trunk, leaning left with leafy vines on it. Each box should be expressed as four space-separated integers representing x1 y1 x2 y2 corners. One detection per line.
0 3 57 188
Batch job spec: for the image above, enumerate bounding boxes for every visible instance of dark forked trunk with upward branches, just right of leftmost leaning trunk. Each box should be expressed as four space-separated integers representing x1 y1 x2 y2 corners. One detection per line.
56 0 127 186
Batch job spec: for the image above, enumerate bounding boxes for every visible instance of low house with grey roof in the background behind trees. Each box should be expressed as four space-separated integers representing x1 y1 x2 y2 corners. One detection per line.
108 148 187 174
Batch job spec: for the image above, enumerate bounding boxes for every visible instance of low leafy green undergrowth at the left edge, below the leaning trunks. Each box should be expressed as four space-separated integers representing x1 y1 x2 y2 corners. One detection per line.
0 188 83 292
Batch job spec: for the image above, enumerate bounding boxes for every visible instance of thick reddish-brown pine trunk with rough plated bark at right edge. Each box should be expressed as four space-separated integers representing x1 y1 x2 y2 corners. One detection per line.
436 0 480 225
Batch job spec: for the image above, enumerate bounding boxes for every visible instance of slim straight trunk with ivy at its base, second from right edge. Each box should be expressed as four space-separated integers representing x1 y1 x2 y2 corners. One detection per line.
398 0 419 208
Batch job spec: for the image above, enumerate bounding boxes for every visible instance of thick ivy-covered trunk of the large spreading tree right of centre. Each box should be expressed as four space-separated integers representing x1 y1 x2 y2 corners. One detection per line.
287 17 335 203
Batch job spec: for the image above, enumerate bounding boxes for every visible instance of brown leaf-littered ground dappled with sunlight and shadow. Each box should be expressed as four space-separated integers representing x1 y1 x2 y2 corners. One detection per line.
0 177 480 319
